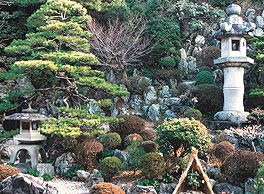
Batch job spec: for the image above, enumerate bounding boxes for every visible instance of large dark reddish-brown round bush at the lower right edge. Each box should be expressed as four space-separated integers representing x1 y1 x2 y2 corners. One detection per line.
221 150 264 183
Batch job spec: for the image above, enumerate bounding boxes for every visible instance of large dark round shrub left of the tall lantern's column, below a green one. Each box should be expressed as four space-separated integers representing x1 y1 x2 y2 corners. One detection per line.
190 84 224 115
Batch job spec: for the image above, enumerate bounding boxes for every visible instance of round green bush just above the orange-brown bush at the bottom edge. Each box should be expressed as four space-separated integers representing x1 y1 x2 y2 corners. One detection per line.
100 156 122 181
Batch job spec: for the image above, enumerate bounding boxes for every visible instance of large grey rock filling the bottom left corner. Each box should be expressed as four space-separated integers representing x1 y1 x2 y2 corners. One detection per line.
0 173 58 194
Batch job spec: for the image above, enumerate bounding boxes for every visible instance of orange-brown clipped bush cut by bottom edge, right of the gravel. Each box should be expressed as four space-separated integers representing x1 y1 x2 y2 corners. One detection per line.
90 183 126 194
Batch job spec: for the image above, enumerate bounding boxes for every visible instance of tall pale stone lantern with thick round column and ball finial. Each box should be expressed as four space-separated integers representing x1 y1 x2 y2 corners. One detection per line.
213 4 255 123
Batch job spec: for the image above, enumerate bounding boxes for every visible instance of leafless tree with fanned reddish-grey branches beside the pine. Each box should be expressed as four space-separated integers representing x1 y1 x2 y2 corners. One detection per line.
87 17 156 85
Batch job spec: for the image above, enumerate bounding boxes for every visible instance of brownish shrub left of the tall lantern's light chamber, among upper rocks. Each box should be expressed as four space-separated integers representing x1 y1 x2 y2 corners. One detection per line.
195 46 221 69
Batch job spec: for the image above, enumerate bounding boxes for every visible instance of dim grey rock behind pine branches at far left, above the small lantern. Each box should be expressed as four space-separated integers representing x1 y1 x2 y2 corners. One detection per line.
14 77 35 98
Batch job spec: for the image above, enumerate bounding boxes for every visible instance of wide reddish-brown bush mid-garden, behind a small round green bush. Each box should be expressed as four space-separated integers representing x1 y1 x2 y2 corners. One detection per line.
109 115 145 140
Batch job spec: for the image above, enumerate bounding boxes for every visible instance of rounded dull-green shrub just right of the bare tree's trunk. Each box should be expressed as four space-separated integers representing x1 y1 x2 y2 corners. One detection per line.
127 75 150 95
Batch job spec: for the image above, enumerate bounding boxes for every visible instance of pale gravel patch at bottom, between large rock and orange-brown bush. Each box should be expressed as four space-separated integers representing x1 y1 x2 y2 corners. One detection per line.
48 178 89 194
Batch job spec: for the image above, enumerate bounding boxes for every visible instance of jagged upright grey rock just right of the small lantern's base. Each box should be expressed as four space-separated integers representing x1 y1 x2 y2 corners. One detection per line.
55 153 74 176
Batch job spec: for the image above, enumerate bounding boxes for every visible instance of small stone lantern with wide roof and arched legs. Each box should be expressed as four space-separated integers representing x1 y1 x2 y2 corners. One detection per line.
5 107 49 170
